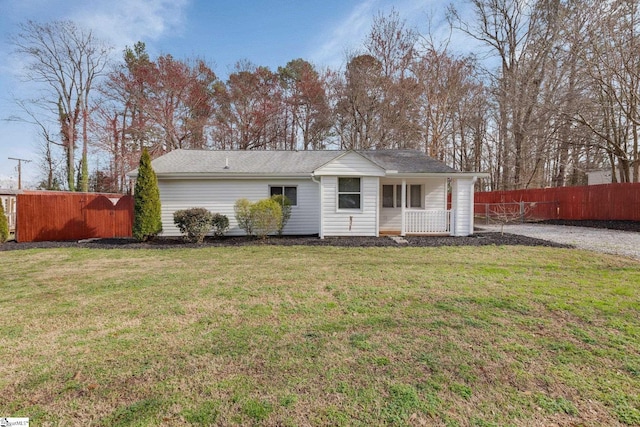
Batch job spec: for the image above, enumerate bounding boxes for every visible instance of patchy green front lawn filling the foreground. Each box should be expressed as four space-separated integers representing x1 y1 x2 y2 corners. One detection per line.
0 245 640 426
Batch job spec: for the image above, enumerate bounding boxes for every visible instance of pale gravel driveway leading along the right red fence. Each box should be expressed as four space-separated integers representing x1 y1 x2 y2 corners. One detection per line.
477 224 640 260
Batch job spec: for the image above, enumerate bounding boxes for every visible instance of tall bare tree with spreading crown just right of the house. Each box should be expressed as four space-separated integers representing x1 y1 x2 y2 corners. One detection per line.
449 0 560 188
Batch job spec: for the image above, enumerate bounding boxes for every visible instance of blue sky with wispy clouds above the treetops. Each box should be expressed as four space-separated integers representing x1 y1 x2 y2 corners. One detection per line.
0 0 470 187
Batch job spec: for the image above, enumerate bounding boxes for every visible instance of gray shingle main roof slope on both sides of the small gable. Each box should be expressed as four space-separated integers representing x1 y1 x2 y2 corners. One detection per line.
146 150 457 176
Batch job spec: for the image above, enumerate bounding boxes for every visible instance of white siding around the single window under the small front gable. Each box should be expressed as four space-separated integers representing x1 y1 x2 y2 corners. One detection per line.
322 176 379 237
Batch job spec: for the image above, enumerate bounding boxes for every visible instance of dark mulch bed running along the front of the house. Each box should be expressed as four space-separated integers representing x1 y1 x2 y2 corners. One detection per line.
0 232 571 251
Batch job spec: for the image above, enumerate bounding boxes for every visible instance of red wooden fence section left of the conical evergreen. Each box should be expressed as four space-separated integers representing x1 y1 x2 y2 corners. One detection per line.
16 191 133 242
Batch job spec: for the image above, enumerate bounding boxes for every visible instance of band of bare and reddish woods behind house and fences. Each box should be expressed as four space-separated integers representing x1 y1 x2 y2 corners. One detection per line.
13 0 640 192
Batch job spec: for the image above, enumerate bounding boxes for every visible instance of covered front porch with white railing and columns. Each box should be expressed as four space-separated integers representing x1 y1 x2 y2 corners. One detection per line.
379 174 475 236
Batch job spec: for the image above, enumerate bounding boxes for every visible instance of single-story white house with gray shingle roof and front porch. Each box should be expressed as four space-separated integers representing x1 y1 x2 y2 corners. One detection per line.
130 150 486 238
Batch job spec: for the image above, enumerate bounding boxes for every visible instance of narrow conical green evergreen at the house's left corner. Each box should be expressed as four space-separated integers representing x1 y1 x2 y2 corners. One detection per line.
133 148 162 242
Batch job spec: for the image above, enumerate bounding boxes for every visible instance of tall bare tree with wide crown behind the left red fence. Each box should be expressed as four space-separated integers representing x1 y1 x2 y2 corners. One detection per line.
12 21 111 191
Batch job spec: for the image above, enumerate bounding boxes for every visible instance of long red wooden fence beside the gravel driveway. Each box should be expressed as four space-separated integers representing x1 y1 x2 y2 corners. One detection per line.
475 182 640 221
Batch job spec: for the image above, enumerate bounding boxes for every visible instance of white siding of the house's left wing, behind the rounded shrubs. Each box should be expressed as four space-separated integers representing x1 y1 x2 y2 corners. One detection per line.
158 179 320 236
